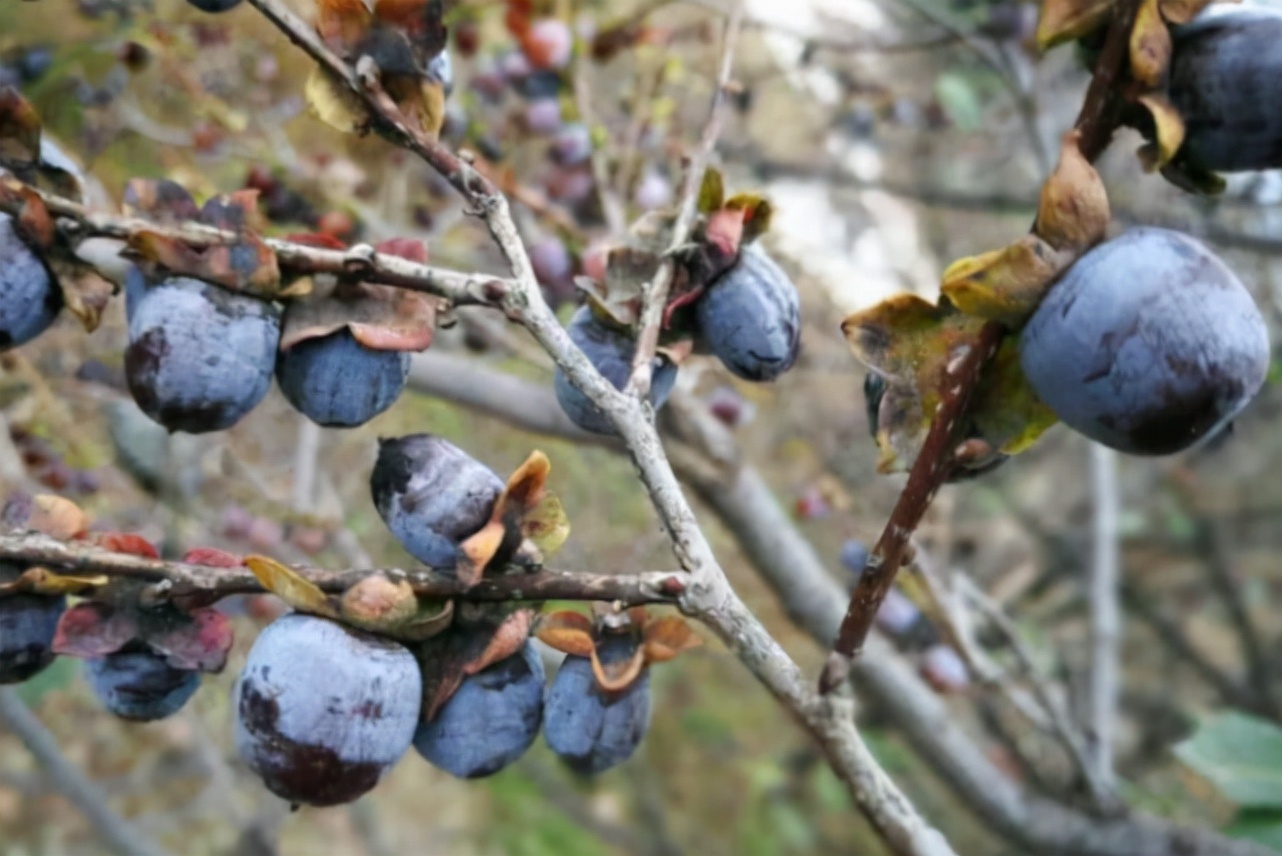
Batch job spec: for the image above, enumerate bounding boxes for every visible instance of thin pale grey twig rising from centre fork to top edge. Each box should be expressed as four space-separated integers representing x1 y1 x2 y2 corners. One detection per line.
627 3 744 399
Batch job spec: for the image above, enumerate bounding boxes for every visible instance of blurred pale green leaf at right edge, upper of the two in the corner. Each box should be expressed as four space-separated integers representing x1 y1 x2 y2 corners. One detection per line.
1176 711 1282 809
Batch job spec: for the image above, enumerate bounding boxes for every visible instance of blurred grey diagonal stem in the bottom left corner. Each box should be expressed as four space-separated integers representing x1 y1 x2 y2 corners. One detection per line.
0 687 175 856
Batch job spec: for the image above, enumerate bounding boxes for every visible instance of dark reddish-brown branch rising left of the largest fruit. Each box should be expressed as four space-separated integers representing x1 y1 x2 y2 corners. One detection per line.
819 0 1140 692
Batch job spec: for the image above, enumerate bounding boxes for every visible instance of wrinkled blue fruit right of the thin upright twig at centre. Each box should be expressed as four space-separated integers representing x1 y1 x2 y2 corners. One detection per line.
695 243 801 381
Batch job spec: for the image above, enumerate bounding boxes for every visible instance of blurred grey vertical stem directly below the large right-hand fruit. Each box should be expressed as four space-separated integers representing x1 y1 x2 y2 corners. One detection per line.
1088 443 1122 789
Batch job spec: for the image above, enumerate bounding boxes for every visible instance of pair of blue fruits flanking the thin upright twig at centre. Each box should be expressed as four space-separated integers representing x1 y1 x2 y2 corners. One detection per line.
555 242 801 433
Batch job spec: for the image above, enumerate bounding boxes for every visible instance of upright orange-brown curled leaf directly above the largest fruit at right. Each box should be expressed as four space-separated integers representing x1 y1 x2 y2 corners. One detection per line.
1033 129 1111 255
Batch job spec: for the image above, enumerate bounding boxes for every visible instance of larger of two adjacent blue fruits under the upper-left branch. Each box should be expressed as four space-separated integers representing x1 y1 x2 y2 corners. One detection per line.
124 272 281 434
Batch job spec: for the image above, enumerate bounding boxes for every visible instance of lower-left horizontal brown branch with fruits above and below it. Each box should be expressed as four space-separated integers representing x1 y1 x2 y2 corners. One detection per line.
0 534 686 606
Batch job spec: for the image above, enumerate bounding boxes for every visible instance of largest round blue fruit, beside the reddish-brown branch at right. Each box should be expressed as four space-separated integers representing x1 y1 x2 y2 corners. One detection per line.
1020 228 1269 455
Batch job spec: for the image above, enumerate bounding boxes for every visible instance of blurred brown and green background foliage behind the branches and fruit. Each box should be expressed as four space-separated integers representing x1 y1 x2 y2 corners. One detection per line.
0 0 1282 856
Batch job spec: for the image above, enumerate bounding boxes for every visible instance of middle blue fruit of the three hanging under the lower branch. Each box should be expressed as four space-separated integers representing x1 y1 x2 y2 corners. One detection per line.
414 642 544 779
